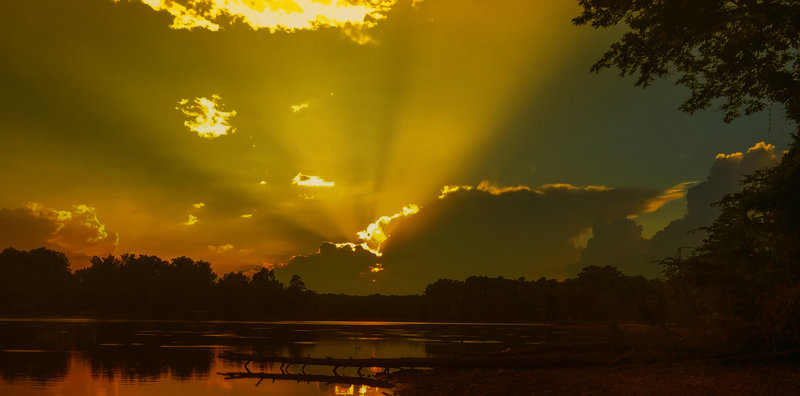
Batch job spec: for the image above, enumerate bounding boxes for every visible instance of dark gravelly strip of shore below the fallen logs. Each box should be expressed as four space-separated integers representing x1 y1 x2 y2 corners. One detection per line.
386 361 800 396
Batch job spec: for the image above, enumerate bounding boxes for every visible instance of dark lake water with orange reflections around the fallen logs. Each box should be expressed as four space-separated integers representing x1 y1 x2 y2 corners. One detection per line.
0 319 568 396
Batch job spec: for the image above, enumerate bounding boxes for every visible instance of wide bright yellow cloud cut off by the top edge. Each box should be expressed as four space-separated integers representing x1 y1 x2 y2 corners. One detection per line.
114 0 396 43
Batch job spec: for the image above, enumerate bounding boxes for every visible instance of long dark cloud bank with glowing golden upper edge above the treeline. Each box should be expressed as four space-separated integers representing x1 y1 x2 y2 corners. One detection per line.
282 182 660 294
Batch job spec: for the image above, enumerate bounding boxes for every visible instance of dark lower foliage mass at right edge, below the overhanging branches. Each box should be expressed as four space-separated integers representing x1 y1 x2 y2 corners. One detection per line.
666 143 800 347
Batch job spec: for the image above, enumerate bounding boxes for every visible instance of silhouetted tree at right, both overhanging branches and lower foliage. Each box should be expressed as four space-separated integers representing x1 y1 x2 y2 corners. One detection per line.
573 0 800 346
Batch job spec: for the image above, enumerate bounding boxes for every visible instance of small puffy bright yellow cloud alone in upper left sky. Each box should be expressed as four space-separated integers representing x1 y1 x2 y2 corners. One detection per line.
176 95 236 139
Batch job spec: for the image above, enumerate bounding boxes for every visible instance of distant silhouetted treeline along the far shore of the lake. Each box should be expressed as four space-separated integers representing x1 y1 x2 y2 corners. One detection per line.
0 248 680 323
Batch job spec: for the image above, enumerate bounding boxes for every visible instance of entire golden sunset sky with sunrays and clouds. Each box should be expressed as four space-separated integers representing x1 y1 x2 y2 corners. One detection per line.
0 0 792 294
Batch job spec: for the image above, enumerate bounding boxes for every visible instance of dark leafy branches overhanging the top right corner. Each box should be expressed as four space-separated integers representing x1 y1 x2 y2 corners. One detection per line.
573 0 800 121
